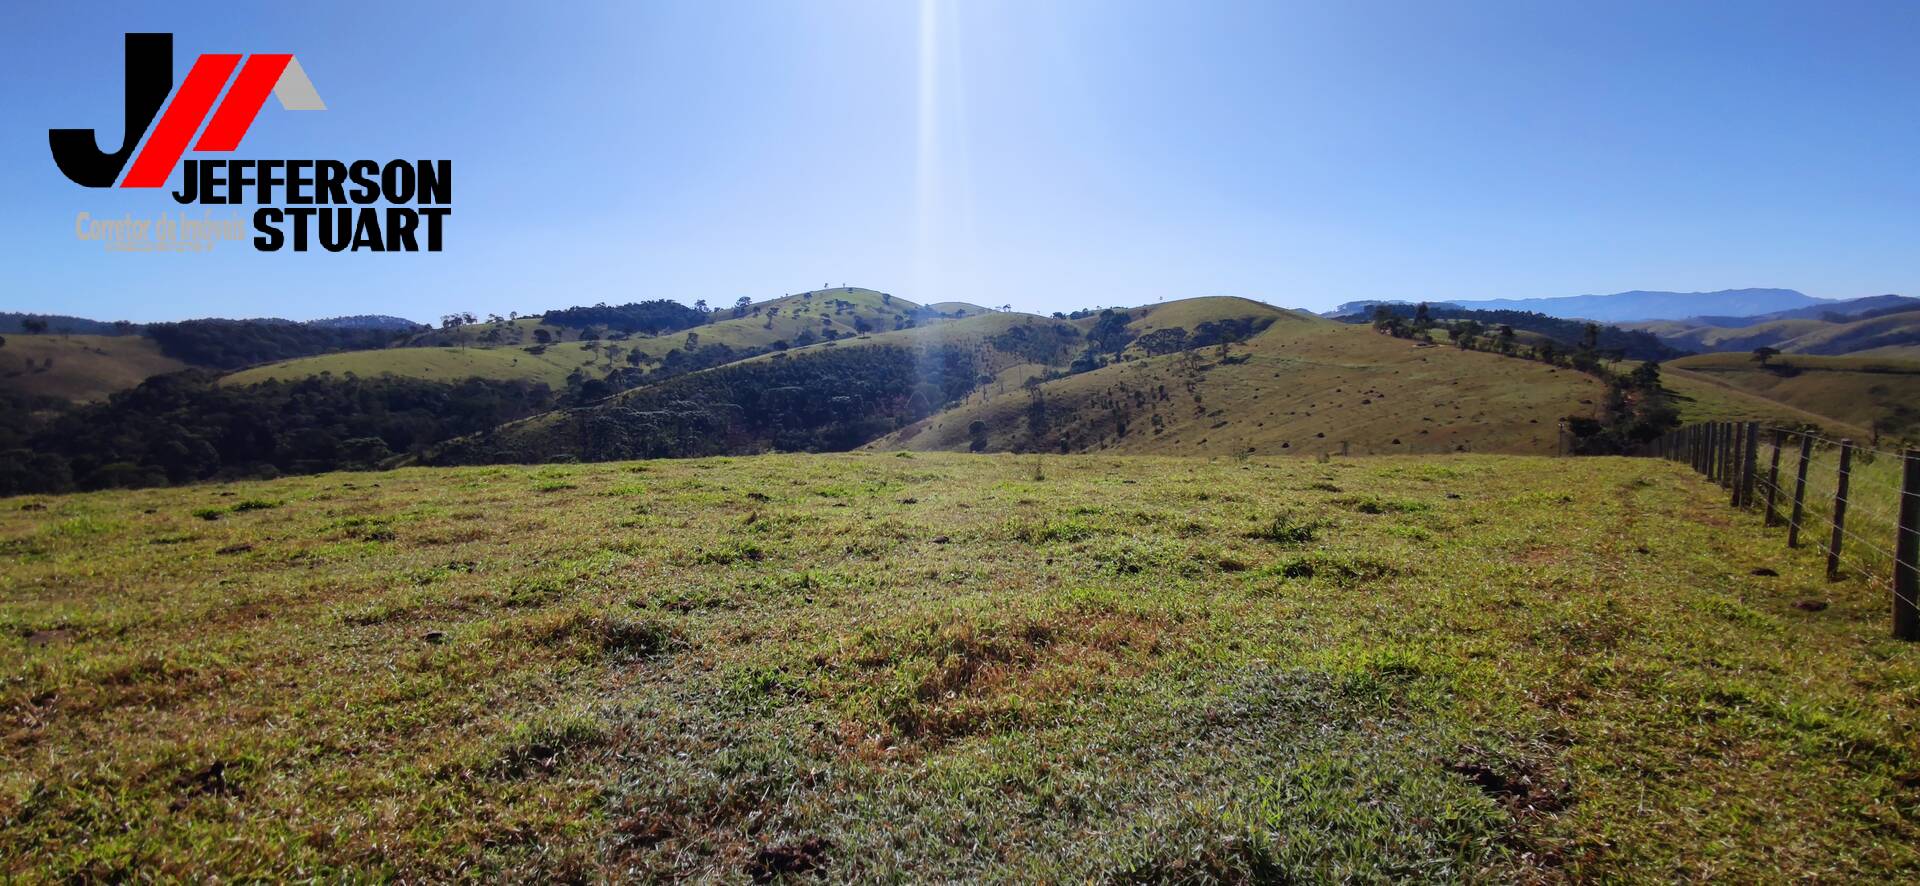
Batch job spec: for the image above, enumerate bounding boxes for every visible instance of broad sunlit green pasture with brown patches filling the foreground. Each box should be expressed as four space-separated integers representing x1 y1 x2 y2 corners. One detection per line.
0 454 1920 880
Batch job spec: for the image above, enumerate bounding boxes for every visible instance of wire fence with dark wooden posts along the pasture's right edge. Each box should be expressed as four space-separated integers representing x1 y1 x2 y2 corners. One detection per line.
1647 421 1920 640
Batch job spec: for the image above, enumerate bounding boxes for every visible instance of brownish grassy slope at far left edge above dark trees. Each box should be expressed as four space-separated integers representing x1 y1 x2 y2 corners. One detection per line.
0 334 186 402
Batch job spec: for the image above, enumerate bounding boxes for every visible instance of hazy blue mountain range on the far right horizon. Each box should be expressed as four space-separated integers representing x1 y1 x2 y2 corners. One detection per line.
1325 288 1920 327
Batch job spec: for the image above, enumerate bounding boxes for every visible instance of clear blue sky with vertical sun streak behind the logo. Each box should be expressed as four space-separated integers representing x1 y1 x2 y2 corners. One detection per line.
0 0 1920 321
